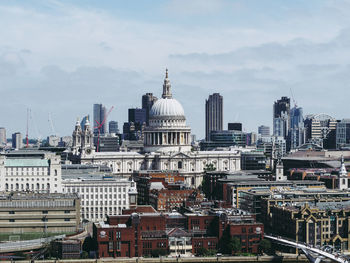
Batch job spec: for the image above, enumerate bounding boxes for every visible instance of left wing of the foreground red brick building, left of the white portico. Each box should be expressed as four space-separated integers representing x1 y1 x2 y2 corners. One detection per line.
93 206 168 258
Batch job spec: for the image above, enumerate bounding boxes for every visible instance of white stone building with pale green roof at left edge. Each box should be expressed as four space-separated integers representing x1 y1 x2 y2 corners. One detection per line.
0 151 62 193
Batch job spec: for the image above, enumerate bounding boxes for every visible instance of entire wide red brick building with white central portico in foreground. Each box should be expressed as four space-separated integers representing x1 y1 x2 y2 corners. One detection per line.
93 206 264 258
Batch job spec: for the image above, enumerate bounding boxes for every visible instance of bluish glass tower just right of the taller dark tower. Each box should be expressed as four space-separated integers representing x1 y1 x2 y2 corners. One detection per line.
289 106 305 149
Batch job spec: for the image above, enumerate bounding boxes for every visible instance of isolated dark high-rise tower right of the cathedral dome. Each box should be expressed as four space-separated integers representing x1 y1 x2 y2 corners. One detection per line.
205 93 223 141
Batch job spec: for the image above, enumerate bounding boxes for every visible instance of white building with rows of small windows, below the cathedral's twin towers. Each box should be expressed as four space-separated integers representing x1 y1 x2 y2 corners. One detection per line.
62 176 137 222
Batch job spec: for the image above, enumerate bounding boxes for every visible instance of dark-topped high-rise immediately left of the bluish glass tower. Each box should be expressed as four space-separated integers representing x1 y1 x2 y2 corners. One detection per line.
273 97 290 139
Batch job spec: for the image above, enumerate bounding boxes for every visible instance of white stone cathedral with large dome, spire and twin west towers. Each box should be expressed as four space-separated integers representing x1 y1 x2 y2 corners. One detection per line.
73 71 241 187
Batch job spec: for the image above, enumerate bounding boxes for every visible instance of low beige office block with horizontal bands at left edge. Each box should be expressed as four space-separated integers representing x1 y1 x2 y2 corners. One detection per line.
0 192 80 236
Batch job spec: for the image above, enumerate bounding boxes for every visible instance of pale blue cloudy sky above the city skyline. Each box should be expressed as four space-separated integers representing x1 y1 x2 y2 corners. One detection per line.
0 0 350 139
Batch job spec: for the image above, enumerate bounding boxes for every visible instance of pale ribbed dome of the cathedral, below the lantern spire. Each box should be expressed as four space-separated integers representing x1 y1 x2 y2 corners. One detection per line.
150 98 185 117
